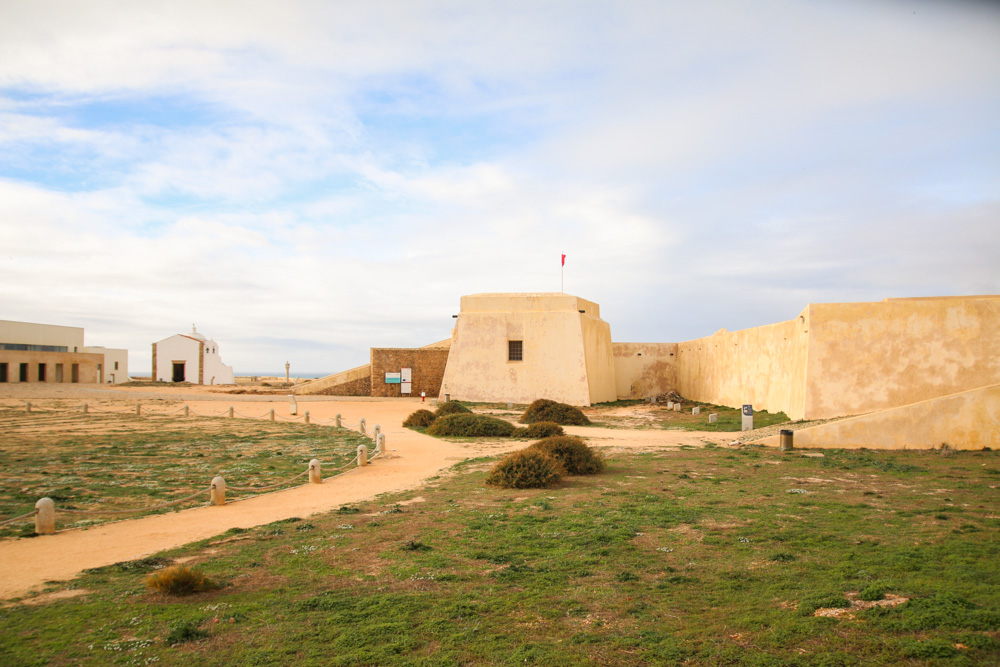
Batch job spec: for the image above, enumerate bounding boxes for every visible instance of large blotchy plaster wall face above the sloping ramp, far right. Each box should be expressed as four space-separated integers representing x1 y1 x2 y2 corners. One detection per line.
804 296 1000 419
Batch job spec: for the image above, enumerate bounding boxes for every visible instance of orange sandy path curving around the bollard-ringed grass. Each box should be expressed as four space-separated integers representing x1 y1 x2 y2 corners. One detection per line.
0 384 726 599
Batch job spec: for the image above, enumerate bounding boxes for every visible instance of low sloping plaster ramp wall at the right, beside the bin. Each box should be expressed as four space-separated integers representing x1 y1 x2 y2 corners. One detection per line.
759 385 1000 449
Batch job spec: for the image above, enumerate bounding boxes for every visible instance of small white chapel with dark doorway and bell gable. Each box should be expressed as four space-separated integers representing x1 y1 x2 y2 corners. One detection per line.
153 325 236 384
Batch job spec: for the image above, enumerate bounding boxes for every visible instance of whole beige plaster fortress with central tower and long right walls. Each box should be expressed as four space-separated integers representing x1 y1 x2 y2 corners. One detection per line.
295 293 1000 448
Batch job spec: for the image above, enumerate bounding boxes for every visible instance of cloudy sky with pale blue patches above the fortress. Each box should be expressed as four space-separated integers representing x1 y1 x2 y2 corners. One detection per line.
0 0 1000 376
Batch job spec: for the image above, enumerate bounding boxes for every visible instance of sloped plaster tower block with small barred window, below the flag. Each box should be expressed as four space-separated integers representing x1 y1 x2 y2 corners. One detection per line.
441 294 615 405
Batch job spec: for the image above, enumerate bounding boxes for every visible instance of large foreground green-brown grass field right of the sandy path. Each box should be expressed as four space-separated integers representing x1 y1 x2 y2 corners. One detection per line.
0 438 1000 665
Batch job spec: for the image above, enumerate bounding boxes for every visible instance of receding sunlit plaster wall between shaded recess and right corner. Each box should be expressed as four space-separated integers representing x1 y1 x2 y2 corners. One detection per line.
677 316 811 419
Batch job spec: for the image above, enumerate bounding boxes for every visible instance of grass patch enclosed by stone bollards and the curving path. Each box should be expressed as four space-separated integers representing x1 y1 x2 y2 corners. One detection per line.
0 410 371 537
